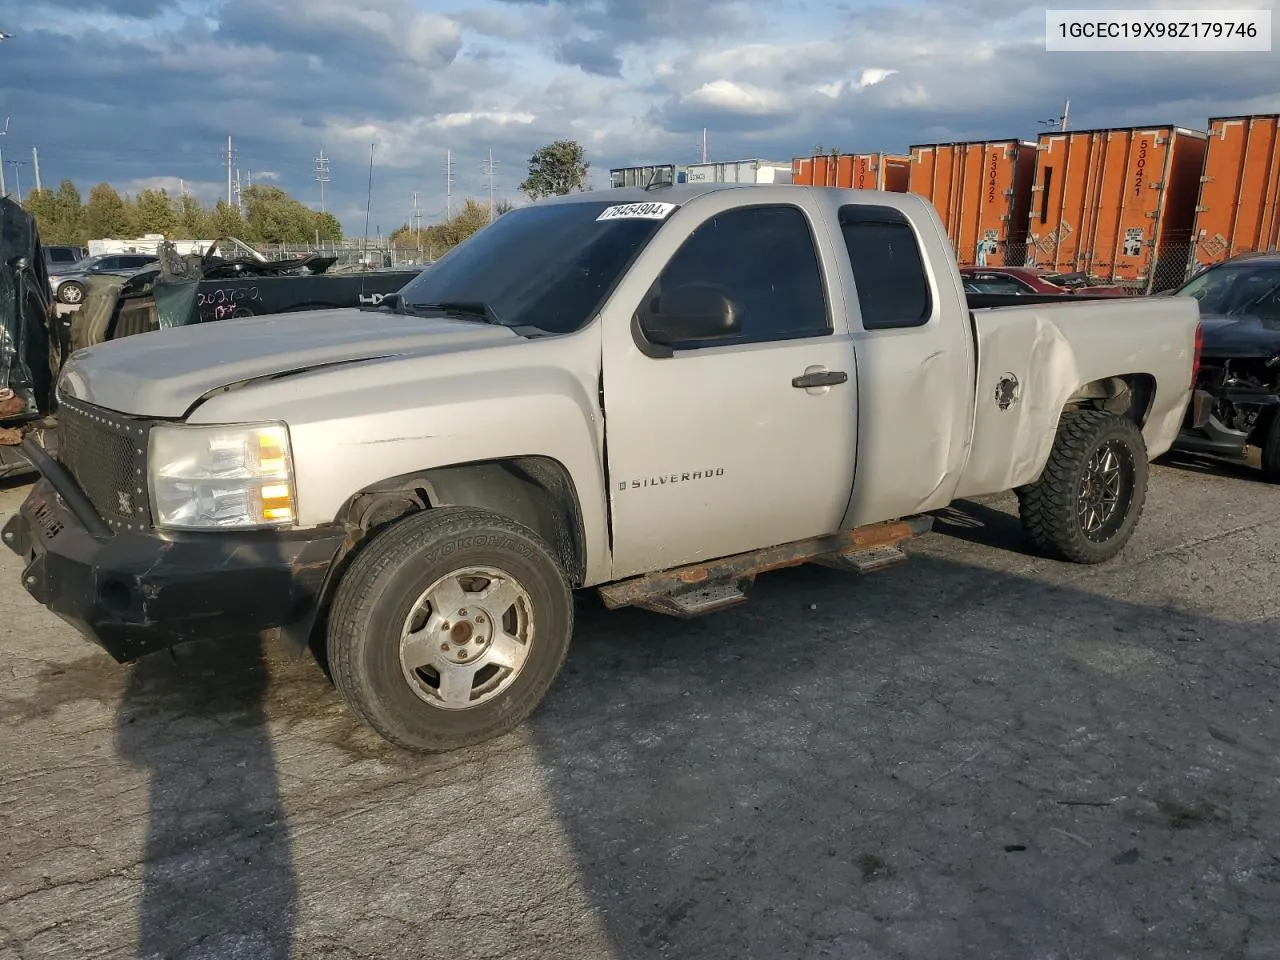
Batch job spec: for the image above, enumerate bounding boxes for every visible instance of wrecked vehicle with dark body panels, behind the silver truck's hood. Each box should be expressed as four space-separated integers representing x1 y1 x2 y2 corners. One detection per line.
68 237 422 349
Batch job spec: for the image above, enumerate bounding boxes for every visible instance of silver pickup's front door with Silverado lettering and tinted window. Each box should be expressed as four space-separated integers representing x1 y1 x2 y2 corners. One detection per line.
603 199 858 579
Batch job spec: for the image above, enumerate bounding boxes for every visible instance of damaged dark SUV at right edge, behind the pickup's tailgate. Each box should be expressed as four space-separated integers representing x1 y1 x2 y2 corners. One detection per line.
1171 252 1280 483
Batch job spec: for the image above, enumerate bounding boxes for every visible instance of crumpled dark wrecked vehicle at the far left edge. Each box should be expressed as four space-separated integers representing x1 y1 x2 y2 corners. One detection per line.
0 197 63 479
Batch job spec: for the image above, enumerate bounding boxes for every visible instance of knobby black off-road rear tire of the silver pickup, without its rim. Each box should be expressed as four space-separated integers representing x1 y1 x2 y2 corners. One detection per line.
1018 410 1148 563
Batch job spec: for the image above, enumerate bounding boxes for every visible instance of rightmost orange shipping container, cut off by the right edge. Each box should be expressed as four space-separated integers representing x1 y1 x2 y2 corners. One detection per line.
1196 114 1280 266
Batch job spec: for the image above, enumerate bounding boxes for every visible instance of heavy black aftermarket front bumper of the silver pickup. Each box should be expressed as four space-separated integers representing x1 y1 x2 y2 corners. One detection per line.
3 442 346 663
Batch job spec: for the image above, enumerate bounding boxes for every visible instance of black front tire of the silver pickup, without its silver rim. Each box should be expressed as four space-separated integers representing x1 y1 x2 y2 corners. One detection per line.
328 507 573 753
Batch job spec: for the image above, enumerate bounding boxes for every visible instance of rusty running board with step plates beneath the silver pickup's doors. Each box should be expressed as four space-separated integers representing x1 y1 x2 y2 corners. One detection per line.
599 516 933 618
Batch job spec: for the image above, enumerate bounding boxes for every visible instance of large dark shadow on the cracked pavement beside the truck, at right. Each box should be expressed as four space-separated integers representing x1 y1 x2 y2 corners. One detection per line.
529 556 1280 960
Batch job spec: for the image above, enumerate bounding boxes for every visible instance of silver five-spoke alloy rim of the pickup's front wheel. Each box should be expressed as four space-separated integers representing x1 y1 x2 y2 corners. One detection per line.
399 567 534 710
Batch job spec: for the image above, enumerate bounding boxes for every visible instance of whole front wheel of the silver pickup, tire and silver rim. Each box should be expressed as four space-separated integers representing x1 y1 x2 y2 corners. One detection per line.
329 507 573 751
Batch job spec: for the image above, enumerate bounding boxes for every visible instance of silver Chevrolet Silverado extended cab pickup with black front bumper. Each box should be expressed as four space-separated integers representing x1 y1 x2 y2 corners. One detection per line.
4 184 1198 750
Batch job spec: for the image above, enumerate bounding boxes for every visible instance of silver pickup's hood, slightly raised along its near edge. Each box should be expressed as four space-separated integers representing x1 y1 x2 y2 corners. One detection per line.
58 307 520 417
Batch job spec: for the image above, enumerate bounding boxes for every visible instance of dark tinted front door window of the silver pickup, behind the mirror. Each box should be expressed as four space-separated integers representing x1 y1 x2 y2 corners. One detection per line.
650 205 832 347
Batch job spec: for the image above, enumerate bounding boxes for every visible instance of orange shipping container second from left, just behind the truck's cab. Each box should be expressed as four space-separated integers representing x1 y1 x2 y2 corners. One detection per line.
910 140 1036 266
